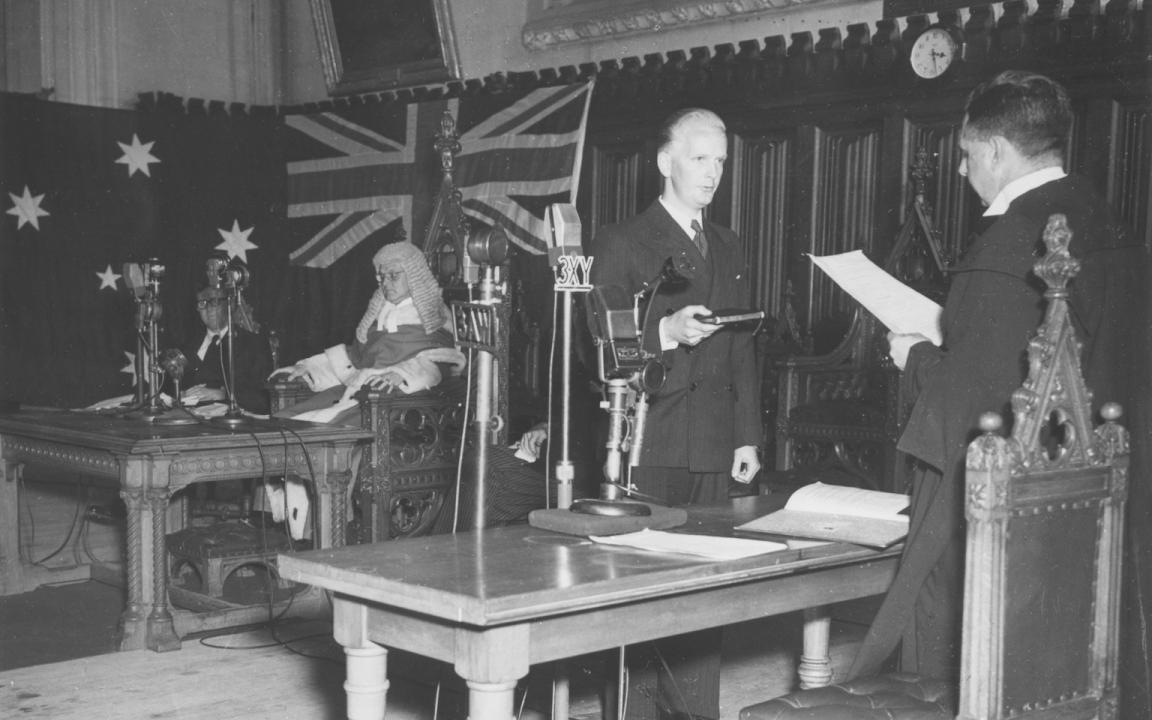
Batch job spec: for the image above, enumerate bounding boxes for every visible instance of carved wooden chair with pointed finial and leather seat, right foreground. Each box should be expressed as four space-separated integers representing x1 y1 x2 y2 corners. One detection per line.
740 215 1128 720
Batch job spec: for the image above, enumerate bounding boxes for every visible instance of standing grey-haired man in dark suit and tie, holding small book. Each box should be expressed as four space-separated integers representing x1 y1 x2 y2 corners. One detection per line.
591 108 761 719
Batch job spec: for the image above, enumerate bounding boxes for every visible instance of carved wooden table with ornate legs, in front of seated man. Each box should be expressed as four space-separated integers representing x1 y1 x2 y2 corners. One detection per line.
0 408 372 651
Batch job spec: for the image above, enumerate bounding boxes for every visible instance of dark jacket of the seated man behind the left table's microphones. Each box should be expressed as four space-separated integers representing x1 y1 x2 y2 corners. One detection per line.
176 327 273 415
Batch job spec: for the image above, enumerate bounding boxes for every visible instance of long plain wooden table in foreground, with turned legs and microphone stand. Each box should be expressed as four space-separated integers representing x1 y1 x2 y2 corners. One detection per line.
279 498 900 720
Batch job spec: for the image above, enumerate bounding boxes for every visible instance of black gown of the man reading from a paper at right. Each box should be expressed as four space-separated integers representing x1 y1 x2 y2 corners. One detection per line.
850 176 1149 676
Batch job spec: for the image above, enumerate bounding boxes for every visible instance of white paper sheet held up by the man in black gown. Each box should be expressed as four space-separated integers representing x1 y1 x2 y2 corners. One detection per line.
809 250 942 346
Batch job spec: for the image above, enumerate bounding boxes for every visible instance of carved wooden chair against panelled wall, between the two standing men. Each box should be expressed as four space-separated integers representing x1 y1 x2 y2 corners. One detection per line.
766 147 948 492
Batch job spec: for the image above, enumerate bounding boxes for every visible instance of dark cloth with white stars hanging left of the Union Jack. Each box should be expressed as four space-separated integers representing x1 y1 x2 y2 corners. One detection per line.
0 93 382 408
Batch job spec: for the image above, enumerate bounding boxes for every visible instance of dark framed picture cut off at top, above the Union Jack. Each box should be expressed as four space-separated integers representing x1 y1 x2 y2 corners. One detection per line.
309 0 461 96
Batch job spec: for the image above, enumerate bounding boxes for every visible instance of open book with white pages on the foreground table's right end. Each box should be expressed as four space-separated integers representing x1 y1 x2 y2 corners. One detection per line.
736 483 909 547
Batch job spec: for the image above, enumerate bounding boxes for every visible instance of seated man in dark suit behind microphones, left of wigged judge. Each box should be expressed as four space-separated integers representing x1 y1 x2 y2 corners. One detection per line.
181 287 272 415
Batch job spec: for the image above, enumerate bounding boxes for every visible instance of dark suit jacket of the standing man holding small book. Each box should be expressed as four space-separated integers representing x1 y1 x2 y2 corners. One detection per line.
591 200 763 472
